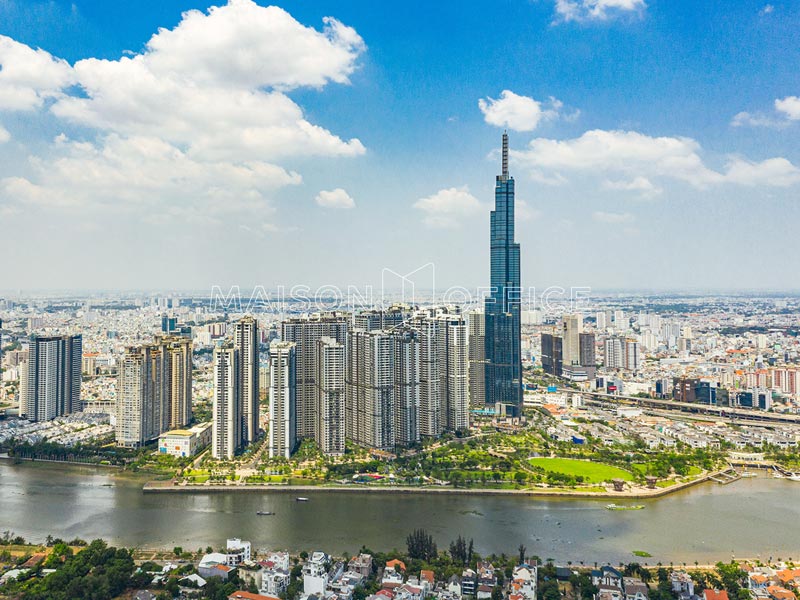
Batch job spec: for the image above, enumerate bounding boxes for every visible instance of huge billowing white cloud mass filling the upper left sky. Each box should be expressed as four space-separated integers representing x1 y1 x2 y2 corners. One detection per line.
0 0 365 220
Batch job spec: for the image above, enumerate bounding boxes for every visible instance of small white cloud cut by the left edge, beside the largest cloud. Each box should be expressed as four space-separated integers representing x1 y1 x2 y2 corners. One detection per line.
0 35 74 111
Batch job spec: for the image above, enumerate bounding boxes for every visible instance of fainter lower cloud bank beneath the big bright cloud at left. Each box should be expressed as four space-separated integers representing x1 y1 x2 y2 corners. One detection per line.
0 134 302 223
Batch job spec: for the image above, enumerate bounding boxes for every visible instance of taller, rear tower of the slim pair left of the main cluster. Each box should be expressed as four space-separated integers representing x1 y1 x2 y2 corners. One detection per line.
233 316 261 444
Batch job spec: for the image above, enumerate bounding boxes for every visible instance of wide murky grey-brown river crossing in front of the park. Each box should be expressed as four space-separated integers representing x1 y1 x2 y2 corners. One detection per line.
0 461 800 565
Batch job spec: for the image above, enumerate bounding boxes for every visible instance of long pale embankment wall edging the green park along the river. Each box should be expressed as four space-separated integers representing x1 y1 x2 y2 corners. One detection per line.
142 472 719 500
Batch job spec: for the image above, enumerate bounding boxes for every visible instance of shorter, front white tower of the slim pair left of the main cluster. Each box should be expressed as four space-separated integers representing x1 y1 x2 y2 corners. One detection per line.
211 344 243 460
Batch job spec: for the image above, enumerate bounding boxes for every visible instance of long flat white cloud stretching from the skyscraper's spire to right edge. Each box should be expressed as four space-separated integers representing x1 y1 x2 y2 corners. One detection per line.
513 129 800 188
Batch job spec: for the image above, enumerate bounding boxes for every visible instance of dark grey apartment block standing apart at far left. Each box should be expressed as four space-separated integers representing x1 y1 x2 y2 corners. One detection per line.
21 335 83 421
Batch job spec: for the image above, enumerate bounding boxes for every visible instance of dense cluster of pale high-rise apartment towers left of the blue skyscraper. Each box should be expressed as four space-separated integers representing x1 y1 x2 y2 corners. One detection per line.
212 307 477 459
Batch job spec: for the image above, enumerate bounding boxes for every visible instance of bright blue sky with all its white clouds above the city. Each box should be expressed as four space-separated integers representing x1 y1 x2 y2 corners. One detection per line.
0 0 800 289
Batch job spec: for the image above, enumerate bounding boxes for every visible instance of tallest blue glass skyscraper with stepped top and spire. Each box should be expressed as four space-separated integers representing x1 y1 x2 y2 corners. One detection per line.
485 133 522 416
